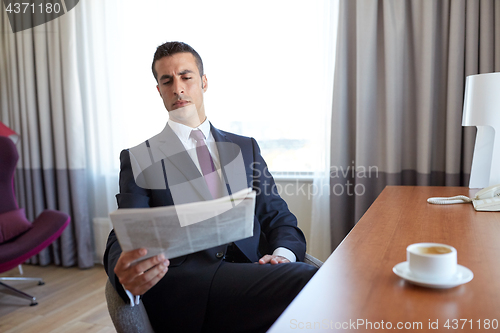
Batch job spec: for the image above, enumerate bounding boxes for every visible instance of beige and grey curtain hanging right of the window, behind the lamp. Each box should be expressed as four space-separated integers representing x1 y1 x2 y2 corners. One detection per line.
330 0 500 248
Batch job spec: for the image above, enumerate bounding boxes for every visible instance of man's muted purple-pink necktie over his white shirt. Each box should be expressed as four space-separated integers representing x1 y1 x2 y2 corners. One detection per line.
190 129 222 199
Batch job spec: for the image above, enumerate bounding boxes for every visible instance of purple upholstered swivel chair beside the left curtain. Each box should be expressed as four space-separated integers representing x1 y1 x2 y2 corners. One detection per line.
0 136 70 306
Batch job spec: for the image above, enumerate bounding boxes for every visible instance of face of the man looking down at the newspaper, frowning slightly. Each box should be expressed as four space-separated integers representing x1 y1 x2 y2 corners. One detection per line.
155 52 207 126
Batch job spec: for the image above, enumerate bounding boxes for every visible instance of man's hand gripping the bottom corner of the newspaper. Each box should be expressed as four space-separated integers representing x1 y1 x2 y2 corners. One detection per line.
114 249 170 296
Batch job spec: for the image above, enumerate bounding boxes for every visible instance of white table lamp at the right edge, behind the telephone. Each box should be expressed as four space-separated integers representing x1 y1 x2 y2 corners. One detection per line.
462 73 500 188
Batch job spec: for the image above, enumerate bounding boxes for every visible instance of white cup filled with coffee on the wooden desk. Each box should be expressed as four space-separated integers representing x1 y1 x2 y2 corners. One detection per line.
406 243 457 280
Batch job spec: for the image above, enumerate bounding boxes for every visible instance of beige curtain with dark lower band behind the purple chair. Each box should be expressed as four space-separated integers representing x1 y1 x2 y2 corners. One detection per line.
0 10 94 268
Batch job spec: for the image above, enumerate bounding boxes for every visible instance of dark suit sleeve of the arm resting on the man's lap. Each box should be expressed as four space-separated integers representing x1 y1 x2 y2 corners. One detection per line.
251 138 306 261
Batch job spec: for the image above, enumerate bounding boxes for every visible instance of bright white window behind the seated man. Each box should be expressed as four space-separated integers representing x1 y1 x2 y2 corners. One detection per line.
112 0 334 174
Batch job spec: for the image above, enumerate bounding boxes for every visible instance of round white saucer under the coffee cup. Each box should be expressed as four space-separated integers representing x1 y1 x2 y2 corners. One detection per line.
392 261 474 289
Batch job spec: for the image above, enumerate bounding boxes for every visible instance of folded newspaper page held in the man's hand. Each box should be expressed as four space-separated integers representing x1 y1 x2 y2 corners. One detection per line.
109 188 255 260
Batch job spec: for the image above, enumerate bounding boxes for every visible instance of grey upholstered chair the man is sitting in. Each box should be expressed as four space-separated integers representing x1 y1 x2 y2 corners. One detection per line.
105 253 323 333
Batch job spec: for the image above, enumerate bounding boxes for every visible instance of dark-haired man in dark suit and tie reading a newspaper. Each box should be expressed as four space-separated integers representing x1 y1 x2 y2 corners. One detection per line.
104 42 316 332
